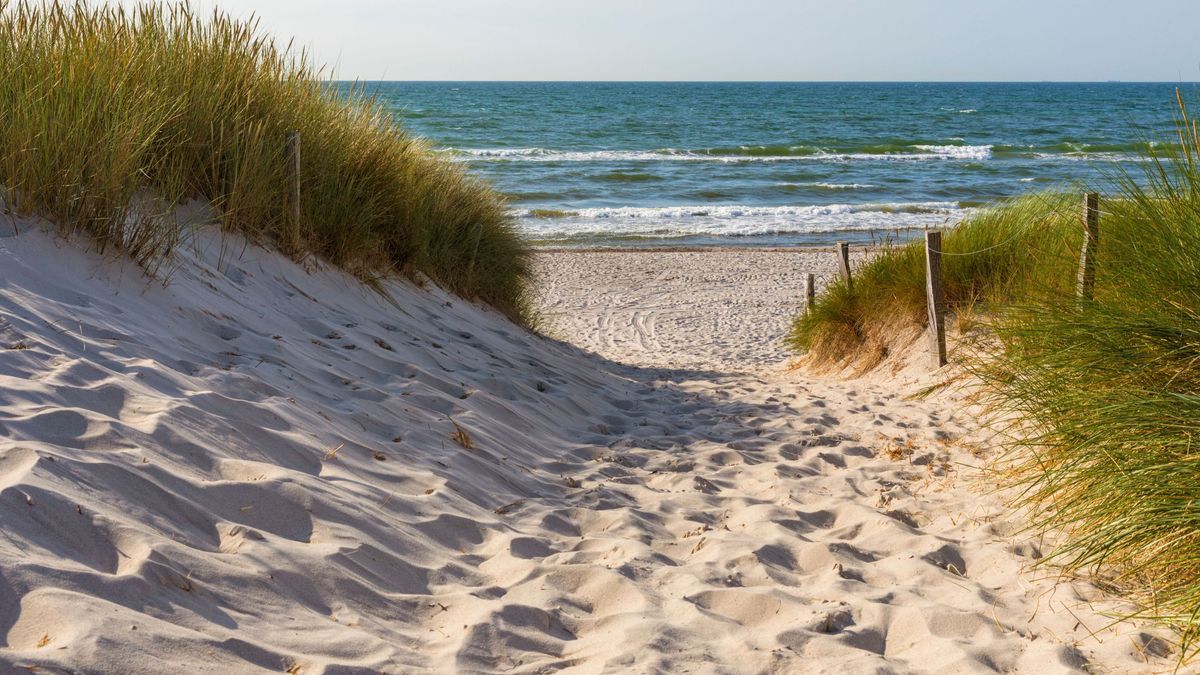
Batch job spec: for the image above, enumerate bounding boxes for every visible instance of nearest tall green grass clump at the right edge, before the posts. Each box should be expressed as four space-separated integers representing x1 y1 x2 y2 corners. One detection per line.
974 101 1200 656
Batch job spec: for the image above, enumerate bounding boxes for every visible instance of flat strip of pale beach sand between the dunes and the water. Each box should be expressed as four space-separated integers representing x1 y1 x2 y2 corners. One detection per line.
536 249 865 370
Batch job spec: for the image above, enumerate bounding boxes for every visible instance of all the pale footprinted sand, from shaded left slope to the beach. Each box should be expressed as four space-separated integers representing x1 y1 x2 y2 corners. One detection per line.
0 227 1172 674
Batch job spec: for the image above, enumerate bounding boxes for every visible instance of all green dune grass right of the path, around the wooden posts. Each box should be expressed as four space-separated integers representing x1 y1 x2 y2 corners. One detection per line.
792 91 1200 658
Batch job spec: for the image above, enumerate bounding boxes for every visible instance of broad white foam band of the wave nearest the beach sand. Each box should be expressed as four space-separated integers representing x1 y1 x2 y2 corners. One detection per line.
515 202 968 239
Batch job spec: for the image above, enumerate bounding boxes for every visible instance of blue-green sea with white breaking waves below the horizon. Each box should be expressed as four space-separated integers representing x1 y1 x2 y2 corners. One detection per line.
366 83 1192 245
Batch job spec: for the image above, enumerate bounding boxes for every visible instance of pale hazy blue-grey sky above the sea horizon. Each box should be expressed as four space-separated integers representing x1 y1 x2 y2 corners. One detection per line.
162 0 1200 82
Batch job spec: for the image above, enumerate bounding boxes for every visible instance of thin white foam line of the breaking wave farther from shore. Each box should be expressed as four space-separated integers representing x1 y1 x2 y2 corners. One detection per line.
449 145 991 163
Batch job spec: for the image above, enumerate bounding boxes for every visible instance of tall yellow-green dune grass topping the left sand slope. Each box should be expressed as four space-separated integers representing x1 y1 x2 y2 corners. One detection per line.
0 0 529 319
